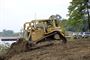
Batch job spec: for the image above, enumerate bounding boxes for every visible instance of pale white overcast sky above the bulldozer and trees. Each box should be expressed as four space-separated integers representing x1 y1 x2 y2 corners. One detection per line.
0 0 72 32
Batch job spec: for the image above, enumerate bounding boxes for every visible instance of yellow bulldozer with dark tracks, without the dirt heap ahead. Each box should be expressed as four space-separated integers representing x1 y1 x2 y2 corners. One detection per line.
23 15 67 46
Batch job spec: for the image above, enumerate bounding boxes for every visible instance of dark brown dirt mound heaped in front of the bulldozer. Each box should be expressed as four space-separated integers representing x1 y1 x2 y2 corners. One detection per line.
5 39 28 60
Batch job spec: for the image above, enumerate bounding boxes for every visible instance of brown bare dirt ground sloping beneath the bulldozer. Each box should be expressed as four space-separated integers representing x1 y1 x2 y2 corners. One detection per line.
1 39 90 60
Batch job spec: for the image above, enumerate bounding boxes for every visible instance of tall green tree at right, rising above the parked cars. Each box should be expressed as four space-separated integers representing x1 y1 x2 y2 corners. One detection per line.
68 0 90 31
